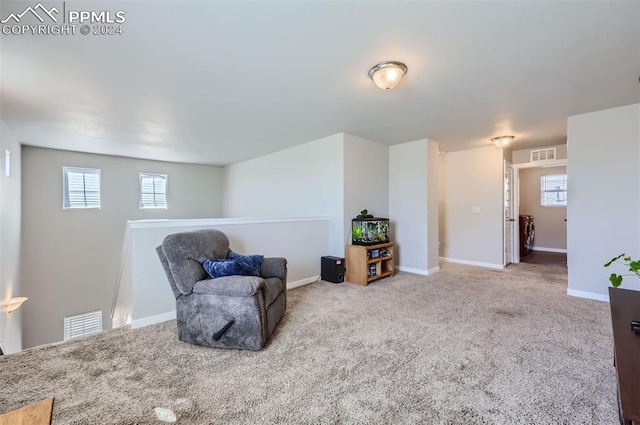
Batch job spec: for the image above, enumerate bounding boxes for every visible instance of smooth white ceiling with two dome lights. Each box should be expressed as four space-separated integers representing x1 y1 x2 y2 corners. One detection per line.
0 1 640 165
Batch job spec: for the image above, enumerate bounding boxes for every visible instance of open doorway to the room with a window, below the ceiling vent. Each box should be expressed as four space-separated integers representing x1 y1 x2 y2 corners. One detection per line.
505 159 568 267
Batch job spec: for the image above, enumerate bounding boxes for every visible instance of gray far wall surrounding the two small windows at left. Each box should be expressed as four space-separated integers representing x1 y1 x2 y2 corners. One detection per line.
21 146 222 347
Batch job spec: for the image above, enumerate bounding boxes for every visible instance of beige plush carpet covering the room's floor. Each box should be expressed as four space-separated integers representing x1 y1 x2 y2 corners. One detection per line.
0 264 617 425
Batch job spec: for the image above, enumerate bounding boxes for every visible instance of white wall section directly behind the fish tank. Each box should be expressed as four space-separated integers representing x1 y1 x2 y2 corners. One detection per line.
343 134 393 245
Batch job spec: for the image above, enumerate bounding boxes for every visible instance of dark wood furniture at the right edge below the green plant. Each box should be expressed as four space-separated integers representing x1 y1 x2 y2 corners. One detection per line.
609 288 640 425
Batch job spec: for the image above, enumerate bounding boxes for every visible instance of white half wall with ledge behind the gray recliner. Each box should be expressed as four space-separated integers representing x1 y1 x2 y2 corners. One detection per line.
114 218 329 327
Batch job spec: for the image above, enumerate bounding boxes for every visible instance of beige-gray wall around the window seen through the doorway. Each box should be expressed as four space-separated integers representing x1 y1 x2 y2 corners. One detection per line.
520 167 567 251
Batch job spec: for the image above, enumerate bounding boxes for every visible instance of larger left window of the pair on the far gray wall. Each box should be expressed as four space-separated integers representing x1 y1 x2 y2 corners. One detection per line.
62 167 100 209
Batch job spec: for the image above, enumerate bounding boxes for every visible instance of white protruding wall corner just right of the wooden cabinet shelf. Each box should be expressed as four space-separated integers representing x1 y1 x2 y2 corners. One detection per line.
389 139 439 274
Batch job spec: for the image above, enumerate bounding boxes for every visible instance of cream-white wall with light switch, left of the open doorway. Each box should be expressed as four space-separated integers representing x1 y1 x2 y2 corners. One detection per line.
440 146 504 268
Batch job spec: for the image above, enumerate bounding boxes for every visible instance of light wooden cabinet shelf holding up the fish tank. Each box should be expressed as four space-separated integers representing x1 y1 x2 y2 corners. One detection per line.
346 242 395 286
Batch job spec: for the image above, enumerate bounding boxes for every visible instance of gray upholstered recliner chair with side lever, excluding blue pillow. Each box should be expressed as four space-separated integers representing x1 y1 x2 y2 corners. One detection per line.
156 230 287 350
